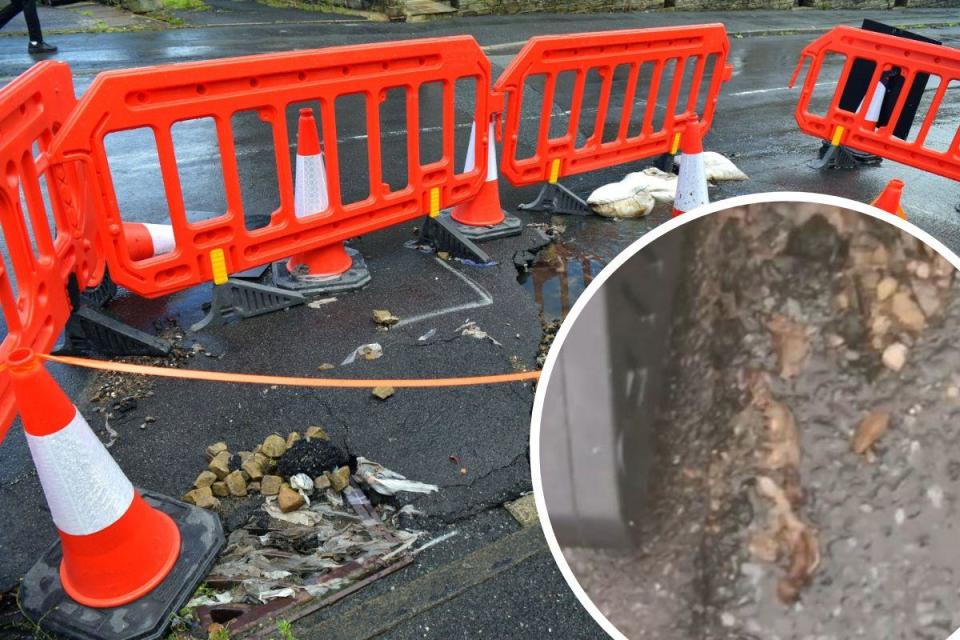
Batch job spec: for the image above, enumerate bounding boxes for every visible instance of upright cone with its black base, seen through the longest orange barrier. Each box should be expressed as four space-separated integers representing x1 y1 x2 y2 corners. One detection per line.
274 108 370 295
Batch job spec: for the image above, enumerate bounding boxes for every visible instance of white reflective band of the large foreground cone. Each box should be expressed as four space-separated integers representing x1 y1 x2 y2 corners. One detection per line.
27 412 133 536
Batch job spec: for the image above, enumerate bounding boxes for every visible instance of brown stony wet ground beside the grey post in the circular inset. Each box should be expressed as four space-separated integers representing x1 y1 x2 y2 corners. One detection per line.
565 204 960 640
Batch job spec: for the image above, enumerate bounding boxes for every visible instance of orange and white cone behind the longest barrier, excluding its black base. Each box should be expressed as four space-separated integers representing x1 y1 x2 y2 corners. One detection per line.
287 107 353 277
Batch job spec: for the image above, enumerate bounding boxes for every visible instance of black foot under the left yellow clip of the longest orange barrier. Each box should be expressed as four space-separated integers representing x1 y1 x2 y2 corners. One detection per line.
190 278 307 331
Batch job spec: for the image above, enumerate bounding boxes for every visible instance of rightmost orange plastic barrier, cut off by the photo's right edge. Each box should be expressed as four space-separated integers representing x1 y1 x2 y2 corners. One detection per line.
790 26 960 180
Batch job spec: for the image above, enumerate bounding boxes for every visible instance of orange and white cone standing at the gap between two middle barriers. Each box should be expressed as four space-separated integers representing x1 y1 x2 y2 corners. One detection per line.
449 119 523 240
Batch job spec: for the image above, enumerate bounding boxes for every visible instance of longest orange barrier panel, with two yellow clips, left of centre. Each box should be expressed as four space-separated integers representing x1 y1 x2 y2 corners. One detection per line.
48 36 490 297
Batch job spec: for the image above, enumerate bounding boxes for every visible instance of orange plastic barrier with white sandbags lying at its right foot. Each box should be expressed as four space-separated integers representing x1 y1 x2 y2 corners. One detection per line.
494 24 732 185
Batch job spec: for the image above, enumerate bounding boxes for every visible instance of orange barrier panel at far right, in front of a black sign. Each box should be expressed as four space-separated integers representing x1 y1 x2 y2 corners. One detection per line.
790 26 960 180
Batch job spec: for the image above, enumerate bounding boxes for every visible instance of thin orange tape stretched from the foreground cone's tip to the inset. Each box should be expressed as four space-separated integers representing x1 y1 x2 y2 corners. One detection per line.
39 354 540 389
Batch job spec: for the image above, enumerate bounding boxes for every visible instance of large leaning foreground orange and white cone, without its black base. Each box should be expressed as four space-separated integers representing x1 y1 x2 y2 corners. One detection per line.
6 349 180 608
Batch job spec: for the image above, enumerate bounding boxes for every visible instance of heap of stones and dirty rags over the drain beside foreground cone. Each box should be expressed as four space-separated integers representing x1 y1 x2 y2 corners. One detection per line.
176 426 438 637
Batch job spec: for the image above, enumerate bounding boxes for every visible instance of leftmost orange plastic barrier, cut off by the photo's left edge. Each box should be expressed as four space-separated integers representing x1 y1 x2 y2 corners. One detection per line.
0 61 105 440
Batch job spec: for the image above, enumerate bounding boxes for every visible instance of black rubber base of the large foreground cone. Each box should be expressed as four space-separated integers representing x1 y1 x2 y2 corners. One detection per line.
20 491 225 640
